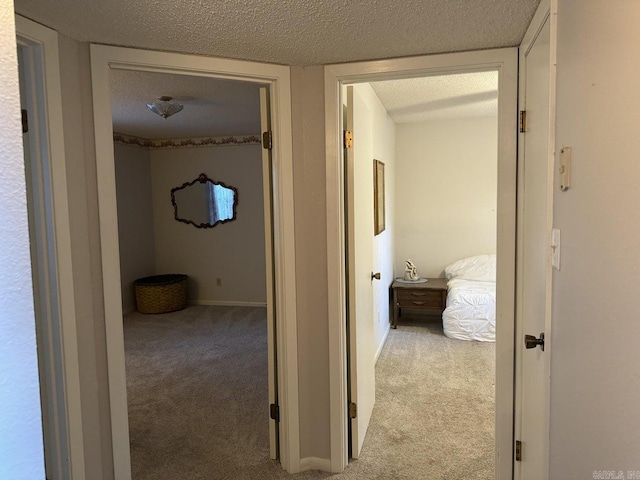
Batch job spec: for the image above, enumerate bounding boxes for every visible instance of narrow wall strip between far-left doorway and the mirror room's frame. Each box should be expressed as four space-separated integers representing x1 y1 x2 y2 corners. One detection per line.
58 35 113 480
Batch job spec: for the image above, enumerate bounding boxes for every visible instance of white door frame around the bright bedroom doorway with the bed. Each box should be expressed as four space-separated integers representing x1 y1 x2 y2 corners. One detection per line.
324 48 518 479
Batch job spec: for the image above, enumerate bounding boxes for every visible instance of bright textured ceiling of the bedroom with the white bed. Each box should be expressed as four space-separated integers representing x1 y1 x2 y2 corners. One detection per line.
371 72 498 124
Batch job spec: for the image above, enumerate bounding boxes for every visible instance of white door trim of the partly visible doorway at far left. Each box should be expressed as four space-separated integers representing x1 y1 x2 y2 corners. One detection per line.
16 15 85 479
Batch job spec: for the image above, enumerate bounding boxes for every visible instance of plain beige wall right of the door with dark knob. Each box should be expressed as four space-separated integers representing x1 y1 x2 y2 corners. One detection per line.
548 0 640 479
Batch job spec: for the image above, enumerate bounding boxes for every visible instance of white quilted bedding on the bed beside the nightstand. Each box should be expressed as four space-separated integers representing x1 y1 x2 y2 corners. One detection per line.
442 278 496 342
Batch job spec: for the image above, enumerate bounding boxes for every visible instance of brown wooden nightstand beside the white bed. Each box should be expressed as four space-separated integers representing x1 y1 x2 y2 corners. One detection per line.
391 278 447 328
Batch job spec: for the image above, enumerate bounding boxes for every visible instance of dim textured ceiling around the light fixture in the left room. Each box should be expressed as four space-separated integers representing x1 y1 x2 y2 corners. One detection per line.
110 70 260 139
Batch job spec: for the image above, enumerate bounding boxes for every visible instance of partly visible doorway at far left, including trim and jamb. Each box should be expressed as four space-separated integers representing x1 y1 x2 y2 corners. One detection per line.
16 16 85 480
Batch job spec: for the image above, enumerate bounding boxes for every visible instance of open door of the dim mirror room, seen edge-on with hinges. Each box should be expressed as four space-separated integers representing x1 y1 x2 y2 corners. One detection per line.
260 87 280 459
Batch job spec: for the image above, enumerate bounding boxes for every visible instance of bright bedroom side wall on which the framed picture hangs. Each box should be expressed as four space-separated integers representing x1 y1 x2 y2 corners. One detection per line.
353 84 397 356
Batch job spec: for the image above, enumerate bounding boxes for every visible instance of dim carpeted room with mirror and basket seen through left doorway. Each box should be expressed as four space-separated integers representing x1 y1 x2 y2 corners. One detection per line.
111 69 279 478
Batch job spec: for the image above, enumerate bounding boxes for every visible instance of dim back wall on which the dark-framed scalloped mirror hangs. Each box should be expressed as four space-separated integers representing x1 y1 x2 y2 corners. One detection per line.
149 145 266 305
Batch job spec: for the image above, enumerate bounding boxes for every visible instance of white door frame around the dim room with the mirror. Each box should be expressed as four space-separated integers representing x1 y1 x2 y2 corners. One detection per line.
90 44 300 480
